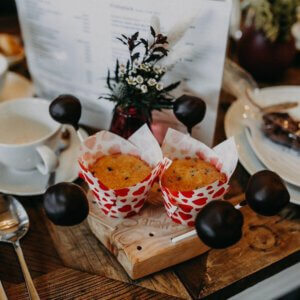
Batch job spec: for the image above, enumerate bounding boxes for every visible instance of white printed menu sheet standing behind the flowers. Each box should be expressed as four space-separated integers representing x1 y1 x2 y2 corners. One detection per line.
16 0 231 145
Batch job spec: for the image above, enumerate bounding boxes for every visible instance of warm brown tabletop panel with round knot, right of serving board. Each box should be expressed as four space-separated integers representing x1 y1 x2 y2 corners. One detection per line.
199 207 300 297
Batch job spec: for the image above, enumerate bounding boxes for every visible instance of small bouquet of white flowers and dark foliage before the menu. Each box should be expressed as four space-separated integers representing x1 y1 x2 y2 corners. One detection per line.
100 26 180 120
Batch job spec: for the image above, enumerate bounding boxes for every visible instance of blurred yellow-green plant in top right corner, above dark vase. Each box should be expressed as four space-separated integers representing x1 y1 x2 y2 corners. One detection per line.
250 0 300 42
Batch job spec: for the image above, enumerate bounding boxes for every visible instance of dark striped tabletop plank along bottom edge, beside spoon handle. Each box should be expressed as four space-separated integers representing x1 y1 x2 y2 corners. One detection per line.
6 268 175 300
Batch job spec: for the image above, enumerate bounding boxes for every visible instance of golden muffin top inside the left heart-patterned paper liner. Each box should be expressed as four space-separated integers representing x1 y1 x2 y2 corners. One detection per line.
90 154 152 190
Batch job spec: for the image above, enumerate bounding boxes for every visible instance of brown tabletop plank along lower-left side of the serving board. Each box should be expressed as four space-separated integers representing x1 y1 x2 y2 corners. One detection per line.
46 216 190 299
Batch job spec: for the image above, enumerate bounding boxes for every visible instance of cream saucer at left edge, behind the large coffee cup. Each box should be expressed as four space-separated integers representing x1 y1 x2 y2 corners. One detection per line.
0 72 34 102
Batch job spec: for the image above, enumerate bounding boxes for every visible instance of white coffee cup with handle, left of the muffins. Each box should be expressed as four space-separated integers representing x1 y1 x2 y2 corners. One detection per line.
0 98 61 175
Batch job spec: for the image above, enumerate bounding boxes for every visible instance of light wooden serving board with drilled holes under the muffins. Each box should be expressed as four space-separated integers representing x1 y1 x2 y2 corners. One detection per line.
88 193 209 279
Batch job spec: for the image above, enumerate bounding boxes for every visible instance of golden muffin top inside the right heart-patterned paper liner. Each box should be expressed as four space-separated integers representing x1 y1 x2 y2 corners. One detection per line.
162 158 226 191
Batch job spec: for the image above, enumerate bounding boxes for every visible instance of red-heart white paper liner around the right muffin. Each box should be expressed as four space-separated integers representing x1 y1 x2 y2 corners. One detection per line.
159 129 238 226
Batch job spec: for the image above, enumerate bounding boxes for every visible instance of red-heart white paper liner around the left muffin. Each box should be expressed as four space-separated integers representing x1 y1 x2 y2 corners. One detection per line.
78 125 168 218
